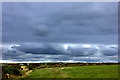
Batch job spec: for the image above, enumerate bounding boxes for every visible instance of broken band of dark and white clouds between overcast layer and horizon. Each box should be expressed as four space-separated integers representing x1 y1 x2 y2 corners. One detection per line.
3 43 117 62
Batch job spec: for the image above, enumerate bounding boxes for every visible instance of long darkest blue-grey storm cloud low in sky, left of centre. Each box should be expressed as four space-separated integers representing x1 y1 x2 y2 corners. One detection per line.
12 44 65 55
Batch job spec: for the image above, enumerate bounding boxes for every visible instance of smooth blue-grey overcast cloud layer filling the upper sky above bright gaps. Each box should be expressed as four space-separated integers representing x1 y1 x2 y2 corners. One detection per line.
3 2 118 44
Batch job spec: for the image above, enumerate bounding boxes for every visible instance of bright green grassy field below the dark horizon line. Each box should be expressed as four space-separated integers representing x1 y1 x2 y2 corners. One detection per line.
29 65 118 78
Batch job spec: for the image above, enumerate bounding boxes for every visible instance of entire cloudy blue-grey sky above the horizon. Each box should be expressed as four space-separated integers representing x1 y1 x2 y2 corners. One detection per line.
2 2 118 62
